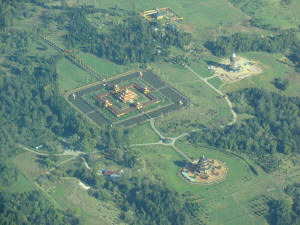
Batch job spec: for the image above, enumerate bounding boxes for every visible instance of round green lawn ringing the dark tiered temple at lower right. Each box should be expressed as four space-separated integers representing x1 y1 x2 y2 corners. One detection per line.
135 143 253 197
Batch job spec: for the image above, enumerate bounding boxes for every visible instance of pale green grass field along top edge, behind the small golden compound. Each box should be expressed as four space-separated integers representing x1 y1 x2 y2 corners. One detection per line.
62 0 247 38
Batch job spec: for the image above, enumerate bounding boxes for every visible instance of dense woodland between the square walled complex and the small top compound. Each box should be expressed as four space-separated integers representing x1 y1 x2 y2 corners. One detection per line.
65 7 191 64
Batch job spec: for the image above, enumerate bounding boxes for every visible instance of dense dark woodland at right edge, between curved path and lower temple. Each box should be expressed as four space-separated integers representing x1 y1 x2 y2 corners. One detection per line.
188 88 300 172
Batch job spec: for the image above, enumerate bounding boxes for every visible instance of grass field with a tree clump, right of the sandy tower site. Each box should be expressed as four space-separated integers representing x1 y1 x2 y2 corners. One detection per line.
222 52 300 96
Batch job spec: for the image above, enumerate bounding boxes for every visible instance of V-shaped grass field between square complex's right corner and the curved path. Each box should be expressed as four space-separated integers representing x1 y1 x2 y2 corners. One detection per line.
154 63 232 136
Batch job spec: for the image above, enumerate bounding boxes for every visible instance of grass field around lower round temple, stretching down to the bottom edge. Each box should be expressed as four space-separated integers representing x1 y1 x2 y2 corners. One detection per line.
132 142 282 225
